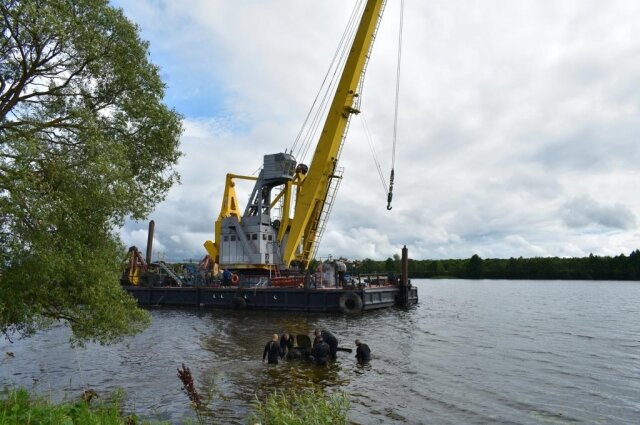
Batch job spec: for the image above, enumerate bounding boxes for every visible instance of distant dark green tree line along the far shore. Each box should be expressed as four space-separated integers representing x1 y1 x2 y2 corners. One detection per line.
349 250 640 280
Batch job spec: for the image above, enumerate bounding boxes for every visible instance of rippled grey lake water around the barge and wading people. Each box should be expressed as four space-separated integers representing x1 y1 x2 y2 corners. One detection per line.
0 280 640 424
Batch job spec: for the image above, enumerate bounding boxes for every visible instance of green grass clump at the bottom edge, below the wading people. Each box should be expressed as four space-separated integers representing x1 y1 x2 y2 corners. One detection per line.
249 389 350 425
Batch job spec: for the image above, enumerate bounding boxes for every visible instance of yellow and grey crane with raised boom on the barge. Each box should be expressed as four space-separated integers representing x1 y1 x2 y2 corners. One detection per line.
204 0 386 270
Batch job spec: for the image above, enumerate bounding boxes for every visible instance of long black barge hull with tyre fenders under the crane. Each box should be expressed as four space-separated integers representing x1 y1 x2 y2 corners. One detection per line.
124 286 418 313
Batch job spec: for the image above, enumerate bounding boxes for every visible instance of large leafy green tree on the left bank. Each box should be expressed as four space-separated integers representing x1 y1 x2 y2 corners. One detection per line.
0 0 182 342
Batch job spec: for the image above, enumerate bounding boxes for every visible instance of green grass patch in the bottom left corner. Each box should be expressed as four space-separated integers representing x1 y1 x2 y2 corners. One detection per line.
0 388 168 425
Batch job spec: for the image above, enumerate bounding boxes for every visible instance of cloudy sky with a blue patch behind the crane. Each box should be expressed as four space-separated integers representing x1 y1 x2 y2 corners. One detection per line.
112 0 640 261
